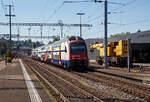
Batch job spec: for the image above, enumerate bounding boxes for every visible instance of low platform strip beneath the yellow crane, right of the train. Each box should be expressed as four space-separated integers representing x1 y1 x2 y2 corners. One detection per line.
90 60 150 85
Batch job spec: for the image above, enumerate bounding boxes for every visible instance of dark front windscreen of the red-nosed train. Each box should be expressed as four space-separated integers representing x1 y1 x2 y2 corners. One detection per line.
70 42 87 53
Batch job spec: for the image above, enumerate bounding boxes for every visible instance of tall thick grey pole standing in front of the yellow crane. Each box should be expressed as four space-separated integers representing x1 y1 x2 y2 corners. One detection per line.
94 0 108 68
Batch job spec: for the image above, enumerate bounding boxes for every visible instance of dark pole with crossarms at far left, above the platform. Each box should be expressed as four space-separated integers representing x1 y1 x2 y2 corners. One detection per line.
5 5 15 48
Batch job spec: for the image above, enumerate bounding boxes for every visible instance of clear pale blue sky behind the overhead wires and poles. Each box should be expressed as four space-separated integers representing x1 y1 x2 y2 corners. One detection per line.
0 0 150 42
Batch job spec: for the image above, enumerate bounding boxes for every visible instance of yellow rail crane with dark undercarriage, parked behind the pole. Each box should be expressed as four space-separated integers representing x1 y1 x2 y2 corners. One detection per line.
89 40 128 66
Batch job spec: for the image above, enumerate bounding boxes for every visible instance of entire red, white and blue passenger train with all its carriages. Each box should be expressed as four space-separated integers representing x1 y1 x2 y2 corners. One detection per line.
31 36 89 68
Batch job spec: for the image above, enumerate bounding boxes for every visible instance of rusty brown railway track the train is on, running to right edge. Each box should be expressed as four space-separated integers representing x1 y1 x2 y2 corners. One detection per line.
73 72 150 100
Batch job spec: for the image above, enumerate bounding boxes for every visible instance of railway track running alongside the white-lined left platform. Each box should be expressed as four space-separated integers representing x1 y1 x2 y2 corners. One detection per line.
24 60 103 102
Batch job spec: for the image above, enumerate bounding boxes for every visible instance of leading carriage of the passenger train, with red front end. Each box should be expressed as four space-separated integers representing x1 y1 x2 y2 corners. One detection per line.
51 36 88 68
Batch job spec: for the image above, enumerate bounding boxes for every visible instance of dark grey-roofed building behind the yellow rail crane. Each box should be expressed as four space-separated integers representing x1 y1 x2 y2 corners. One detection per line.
86 30 150 63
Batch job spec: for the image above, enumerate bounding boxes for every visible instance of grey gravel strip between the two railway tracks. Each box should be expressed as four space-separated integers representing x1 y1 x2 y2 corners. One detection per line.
40 63 148 102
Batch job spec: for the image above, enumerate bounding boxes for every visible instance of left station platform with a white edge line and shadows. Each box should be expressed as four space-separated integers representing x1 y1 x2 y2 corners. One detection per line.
0 59 51 102
